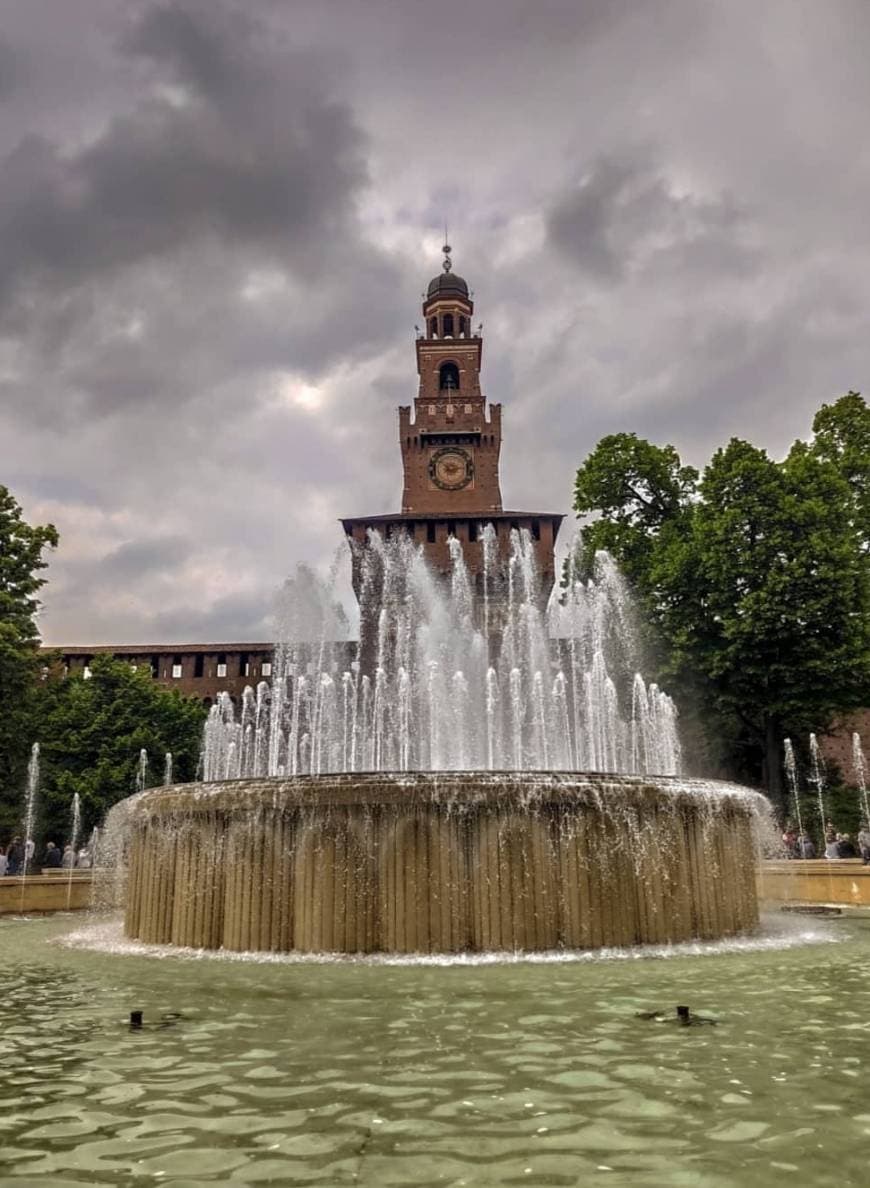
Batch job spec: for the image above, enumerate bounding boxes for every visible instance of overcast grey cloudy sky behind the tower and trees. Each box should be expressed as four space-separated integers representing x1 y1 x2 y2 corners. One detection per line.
0 0 870 643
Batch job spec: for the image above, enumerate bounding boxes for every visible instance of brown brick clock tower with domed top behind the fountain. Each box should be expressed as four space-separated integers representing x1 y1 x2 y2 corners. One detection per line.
341 245 562 622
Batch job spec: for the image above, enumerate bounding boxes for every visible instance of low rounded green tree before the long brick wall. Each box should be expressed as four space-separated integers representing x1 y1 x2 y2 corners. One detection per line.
27 656 206 843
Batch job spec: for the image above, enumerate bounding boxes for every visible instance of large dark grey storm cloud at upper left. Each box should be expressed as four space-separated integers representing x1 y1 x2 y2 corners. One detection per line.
0 5 366 316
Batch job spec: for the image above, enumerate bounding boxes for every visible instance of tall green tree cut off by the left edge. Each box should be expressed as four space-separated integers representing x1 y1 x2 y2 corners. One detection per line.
0 486 57 810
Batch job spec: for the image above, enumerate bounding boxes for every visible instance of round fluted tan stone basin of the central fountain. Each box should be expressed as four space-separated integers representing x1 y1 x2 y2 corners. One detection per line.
119 771 767 953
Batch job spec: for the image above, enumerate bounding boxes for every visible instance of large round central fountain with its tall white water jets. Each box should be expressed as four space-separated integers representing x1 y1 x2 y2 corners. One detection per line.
107 531 767 953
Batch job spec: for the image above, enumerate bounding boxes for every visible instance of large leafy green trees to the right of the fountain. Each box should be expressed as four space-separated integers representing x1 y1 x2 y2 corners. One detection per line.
575 393 870 795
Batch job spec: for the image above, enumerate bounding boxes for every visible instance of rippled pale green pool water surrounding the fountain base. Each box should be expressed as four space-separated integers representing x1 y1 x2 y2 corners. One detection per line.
0 917 870 1188
